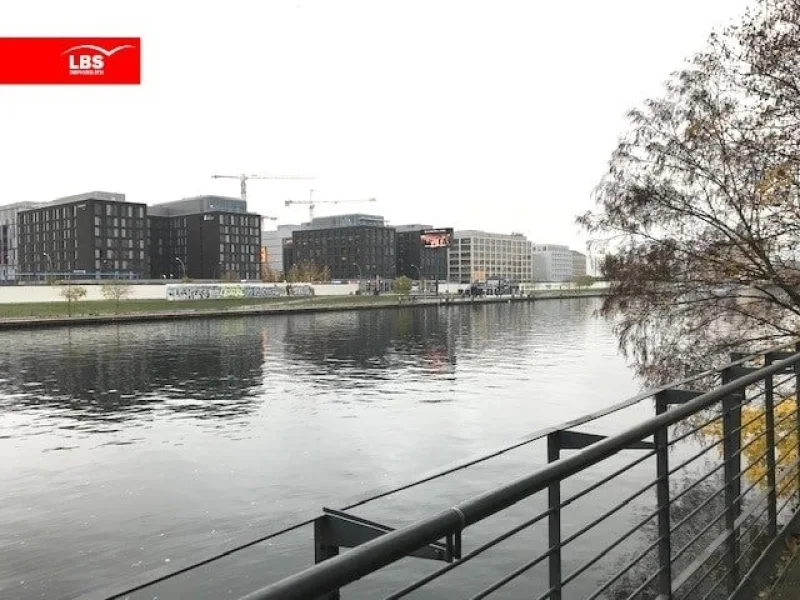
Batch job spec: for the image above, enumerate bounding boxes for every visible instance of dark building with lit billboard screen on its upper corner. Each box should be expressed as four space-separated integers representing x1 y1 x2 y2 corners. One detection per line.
395 225 453 281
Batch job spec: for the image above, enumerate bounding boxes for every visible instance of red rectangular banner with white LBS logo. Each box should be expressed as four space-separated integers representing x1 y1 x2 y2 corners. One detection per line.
0 38 141 85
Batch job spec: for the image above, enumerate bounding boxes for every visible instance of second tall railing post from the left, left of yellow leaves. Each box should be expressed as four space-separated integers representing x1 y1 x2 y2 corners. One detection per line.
653 392 672 600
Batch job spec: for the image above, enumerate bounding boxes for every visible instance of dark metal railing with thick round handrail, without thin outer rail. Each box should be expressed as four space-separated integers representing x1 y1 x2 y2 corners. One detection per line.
234 347 800 600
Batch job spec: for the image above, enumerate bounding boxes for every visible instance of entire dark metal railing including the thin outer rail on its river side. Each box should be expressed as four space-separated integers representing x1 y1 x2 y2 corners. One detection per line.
101 342 800 600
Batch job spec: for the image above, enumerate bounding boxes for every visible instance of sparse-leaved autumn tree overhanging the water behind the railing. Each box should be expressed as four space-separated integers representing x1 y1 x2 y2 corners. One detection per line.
578 0 800 384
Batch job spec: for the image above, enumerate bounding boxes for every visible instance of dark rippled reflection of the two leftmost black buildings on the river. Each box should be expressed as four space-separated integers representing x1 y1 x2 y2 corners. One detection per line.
0 321 263 435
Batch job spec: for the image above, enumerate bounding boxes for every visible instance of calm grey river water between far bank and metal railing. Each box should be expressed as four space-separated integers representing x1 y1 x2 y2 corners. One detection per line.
0 299 636 598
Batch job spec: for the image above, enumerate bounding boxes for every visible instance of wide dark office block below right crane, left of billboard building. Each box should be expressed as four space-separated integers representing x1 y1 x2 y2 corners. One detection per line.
284 214 397 279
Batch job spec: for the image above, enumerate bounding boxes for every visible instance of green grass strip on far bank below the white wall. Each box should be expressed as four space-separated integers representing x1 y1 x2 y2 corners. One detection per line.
0 295 398 319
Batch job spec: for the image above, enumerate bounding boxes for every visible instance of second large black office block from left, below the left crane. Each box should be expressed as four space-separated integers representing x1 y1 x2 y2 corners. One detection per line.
148 196 261 280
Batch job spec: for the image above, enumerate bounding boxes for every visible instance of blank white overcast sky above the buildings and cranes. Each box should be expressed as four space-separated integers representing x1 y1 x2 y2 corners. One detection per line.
0 0 747 250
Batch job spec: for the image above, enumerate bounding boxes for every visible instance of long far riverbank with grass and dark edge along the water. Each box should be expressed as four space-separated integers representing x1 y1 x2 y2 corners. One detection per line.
0 289 606 329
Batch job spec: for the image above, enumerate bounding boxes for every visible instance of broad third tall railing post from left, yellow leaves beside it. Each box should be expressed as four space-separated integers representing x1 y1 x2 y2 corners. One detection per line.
722 369 745 593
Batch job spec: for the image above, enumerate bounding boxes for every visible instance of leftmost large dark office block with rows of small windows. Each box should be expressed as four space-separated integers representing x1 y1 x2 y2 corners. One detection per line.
17 192 150 278
